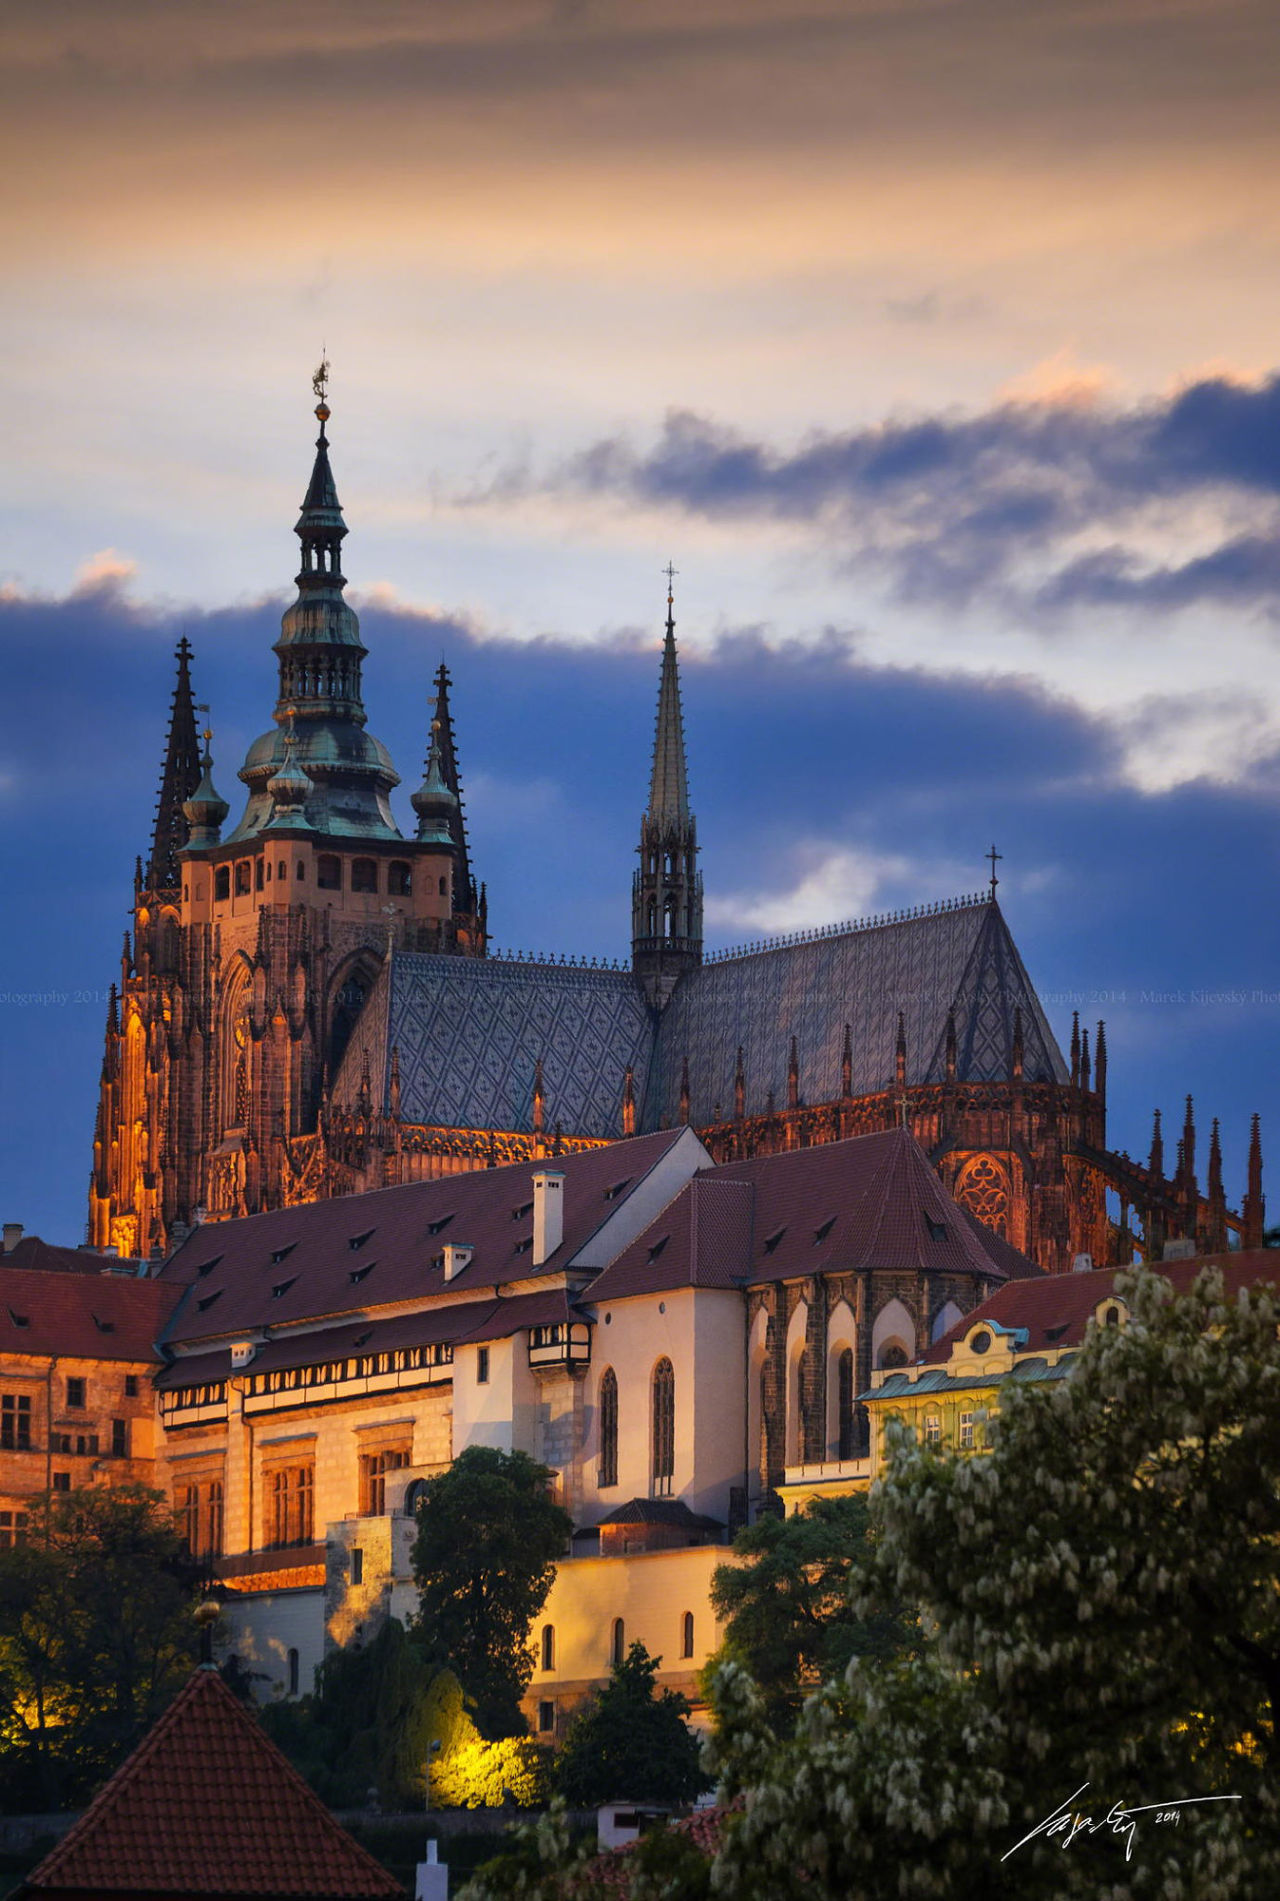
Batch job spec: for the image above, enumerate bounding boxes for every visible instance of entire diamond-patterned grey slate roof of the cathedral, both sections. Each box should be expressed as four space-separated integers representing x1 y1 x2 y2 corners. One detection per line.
335 899 1069 1137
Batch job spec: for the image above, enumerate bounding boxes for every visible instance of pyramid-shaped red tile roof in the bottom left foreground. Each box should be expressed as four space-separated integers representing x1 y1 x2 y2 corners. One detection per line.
27 1669 403 1901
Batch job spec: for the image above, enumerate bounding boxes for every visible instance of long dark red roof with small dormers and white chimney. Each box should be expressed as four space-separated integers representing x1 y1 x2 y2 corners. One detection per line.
162 1129 687 1340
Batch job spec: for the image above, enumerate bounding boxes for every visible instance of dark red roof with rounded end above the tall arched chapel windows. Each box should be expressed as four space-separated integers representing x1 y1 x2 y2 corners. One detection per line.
584 1129 1040 1304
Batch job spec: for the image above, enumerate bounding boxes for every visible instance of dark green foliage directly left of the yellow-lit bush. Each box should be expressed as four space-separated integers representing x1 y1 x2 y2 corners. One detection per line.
262 1618 434 1810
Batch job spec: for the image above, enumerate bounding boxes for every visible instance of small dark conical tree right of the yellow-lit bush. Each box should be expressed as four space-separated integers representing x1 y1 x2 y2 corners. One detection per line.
555 1642 706 1808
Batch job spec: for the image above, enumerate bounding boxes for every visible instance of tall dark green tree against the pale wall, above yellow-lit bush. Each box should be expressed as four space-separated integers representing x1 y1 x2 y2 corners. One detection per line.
413 1447 572 1739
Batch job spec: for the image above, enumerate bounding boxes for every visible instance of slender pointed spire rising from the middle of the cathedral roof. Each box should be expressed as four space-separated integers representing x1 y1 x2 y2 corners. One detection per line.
631 568 702 1009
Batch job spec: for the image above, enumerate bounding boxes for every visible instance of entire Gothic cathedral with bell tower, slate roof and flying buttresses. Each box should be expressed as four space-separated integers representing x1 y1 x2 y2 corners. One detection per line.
89 394 1263 1272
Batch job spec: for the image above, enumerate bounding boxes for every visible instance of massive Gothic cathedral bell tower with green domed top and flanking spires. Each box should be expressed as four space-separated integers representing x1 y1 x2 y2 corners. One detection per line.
89 378 485 1253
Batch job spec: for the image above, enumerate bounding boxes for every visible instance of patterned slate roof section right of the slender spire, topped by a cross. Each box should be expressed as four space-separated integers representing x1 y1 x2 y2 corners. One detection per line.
643 897 1069 1127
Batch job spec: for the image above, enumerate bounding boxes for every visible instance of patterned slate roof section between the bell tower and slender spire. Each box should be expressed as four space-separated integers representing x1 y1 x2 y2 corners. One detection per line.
333 952 654 1139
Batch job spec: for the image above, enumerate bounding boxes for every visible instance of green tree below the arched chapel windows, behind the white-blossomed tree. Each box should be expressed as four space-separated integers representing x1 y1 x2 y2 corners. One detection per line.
704 1496 915 1730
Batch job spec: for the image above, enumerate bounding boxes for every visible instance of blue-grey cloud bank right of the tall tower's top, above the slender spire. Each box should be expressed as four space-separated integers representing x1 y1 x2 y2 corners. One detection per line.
484 378 1280 618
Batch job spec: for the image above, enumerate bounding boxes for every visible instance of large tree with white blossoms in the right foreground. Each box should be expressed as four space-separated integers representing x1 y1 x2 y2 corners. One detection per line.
703 1272 1280 1901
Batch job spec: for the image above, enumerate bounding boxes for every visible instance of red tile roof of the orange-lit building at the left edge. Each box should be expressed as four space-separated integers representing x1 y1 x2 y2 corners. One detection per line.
0 1255 181 1365
